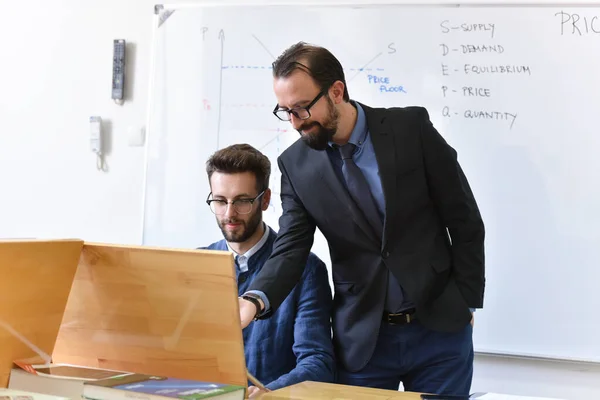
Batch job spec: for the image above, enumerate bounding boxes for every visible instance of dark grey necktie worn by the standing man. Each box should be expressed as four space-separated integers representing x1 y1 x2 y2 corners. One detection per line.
339 143 404 312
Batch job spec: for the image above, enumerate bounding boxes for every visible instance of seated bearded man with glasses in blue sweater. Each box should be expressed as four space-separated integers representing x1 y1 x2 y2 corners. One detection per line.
204 144 335 397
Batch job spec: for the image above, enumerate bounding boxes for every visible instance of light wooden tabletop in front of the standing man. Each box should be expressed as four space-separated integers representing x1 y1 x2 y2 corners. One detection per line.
260 381 421 400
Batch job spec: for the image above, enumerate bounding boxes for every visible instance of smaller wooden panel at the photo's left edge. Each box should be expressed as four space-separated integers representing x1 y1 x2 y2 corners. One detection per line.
0 240 83 387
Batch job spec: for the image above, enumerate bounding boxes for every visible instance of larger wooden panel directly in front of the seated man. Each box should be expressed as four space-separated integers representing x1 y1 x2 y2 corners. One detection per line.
53 243 247 386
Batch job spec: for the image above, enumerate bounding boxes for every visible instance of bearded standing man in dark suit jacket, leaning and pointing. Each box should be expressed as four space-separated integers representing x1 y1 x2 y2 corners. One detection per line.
240 43 485 395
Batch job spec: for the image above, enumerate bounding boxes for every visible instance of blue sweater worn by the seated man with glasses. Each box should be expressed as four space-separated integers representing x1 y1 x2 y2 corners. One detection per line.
204 228 335 390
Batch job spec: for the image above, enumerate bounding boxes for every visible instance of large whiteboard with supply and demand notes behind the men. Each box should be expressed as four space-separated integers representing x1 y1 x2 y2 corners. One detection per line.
144 6 600 362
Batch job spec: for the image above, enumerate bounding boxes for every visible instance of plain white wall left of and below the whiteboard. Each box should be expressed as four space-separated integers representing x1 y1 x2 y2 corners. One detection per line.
0 0 600 399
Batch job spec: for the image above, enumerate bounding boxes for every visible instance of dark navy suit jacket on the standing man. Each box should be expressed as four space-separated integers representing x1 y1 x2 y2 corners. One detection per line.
249 104 485 372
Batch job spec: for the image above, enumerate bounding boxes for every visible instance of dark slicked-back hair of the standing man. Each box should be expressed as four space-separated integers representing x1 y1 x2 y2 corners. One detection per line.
273 42 350 101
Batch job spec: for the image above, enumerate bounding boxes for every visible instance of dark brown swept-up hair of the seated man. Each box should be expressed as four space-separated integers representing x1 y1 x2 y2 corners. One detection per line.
206 144 271 191
